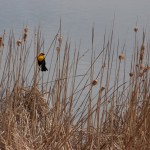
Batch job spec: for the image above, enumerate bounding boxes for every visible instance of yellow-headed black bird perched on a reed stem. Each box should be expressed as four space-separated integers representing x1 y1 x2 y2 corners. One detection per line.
37 53 48 71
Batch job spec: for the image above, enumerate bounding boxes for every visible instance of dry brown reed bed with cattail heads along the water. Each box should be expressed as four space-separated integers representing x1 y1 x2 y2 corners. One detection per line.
0 24 150 150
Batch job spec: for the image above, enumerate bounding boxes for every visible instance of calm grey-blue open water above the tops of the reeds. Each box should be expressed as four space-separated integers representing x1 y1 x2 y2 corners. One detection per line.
0 0 150 86
